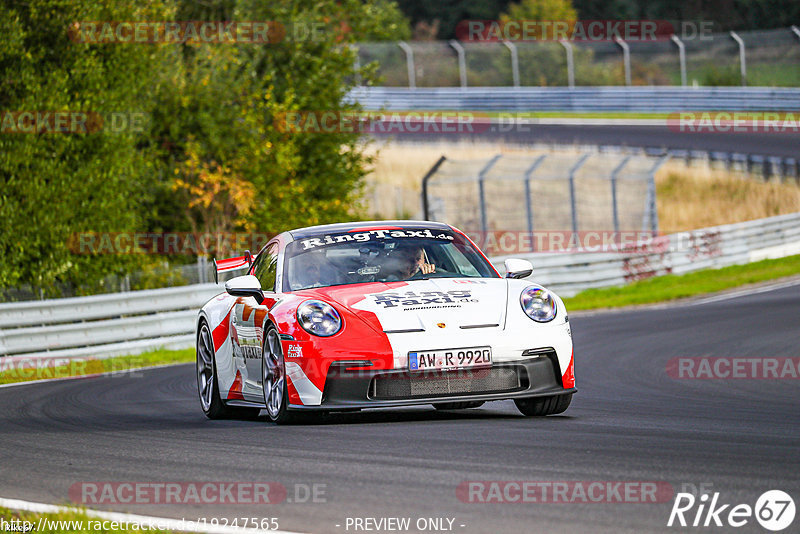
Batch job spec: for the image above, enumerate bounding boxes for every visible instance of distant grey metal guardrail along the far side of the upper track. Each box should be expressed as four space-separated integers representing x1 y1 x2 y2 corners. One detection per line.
347 86 800 113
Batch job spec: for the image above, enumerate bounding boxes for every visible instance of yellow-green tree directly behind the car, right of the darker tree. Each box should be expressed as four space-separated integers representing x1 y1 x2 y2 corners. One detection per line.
142 0 409 247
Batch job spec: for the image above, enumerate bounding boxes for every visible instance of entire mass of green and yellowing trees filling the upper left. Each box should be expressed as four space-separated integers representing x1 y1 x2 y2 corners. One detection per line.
0 0 410 295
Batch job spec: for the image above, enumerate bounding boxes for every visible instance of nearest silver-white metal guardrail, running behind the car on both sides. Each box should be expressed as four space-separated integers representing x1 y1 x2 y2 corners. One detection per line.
0 213 800 359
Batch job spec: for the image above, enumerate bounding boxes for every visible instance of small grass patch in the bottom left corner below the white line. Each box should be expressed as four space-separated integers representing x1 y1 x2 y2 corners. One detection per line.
0 508 175 534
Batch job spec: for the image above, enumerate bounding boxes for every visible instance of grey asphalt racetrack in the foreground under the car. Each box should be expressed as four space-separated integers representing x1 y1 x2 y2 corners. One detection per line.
0 285 800 533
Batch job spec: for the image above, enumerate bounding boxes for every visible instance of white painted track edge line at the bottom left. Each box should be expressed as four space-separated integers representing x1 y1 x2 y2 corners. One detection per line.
0 497 298 534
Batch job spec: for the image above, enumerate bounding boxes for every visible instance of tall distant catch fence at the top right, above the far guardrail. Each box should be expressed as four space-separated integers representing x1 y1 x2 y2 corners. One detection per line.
354 26 800 88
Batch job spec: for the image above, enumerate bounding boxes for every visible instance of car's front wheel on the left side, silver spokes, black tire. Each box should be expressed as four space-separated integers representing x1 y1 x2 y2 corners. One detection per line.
261 325 297 425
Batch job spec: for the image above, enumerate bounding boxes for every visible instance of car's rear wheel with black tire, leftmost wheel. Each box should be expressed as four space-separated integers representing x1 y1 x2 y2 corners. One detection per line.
197 321 261 419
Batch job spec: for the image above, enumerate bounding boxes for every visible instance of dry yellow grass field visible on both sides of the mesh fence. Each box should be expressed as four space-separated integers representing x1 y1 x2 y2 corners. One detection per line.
365 142 800 233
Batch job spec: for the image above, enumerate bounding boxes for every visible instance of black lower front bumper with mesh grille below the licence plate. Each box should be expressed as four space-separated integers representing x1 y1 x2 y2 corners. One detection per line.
289 349 577 410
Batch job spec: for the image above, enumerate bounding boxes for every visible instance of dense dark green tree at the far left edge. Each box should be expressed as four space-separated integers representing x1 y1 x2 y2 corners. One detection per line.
0 0 169 294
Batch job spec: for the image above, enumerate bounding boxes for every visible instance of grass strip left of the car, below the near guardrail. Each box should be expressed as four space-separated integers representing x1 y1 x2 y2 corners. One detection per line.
0 349 195 384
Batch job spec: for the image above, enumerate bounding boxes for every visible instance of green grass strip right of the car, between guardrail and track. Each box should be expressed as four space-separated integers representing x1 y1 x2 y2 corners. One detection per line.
564 256 800 312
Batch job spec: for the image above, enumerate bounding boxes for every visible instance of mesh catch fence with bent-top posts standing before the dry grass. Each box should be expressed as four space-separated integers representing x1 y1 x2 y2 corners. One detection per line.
422 152 666 242
